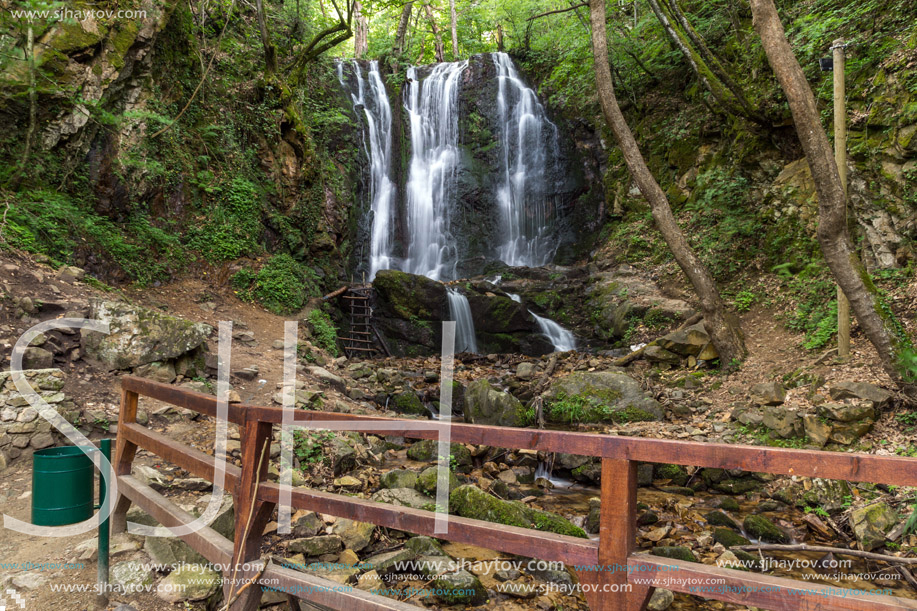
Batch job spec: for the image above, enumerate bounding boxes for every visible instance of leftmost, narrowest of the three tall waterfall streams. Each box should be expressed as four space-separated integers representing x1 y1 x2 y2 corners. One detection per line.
337 60 396 280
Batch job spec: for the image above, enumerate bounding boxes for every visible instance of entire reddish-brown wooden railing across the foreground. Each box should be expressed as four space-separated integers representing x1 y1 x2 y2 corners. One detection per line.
112 376 917 611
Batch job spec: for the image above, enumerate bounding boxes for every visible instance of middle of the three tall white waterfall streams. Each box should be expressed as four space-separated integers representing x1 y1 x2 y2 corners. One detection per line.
404 61 474 282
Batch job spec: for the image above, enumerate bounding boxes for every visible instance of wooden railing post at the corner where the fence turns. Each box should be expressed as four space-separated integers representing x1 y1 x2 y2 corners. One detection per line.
223 419 274 611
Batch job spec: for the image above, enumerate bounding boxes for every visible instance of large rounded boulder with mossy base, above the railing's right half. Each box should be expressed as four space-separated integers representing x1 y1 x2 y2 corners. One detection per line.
544 371 663 423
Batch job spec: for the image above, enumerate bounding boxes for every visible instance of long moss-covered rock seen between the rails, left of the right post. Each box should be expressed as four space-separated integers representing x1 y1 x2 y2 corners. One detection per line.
449 485 587 538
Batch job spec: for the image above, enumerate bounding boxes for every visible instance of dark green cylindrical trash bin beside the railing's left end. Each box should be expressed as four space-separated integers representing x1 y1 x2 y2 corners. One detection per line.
32 446 99 526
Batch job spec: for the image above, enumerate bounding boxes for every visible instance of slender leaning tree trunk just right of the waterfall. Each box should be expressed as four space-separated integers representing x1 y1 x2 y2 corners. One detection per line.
589 0 747 368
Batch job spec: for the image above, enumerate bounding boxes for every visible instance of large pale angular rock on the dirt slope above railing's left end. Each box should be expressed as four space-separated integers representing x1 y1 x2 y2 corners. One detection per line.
81 299 213 369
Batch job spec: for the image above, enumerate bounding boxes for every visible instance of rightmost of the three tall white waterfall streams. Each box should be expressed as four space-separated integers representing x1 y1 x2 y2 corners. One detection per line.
493 53 558 267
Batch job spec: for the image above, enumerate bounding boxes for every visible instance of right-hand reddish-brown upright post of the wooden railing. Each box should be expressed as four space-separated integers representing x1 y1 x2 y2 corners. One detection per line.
578 458 652 611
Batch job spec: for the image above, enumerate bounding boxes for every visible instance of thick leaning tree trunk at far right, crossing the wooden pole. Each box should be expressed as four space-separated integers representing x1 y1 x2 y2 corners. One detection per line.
751 0 917 400
